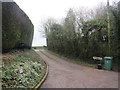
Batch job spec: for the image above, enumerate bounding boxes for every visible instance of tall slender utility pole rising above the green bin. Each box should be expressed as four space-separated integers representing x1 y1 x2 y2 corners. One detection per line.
107 0 111 55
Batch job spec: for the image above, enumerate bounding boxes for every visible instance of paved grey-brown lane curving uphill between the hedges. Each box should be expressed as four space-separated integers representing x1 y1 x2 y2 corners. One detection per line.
36 49 118 88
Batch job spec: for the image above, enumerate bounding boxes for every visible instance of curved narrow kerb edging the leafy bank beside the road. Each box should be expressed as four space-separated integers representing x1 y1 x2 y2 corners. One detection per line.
34 51 49 90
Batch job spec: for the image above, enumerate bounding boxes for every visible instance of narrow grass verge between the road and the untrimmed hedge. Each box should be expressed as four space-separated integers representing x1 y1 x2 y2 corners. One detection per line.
41 47 120 71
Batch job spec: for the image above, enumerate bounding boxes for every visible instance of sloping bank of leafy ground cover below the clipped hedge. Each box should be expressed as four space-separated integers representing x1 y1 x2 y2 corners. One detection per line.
2 50 46 89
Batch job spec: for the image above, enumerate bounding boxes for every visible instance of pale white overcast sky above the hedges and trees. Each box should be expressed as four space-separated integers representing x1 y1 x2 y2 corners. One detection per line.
14 0 117 46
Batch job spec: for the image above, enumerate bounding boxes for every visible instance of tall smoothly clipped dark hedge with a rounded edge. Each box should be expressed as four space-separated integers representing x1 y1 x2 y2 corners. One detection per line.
2 2 34 52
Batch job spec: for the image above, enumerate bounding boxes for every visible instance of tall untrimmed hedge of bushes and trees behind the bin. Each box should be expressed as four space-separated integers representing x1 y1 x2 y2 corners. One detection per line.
45 2 120 66
